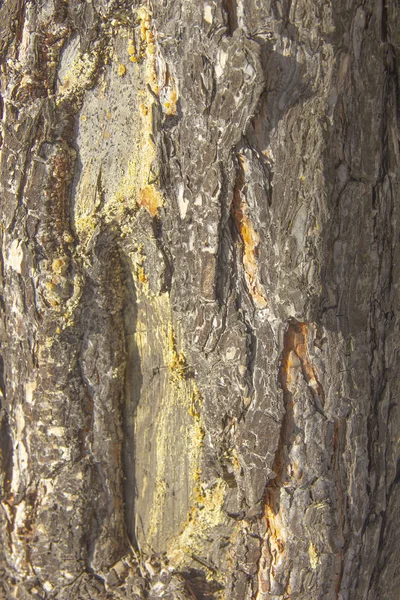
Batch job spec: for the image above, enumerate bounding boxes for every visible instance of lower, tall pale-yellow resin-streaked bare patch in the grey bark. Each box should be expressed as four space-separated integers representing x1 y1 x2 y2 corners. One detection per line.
134 292 204 547
